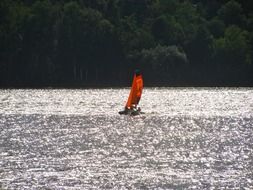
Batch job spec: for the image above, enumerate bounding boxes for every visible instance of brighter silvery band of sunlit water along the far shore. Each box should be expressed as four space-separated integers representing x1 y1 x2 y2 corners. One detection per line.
0 88 253 117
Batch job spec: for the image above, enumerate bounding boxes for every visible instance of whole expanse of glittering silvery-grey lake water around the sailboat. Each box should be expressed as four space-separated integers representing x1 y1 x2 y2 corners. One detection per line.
0 88 253 190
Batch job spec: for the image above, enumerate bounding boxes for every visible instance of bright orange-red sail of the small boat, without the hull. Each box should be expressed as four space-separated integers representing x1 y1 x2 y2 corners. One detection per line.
126 75 143 108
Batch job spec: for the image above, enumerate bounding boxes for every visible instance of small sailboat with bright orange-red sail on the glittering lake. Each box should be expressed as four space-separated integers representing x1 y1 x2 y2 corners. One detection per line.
119 70 143 115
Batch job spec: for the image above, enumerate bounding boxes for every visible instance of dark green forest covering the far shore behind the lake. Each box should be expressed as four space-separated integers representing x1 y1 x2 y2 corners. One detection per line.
0 0 253 88
